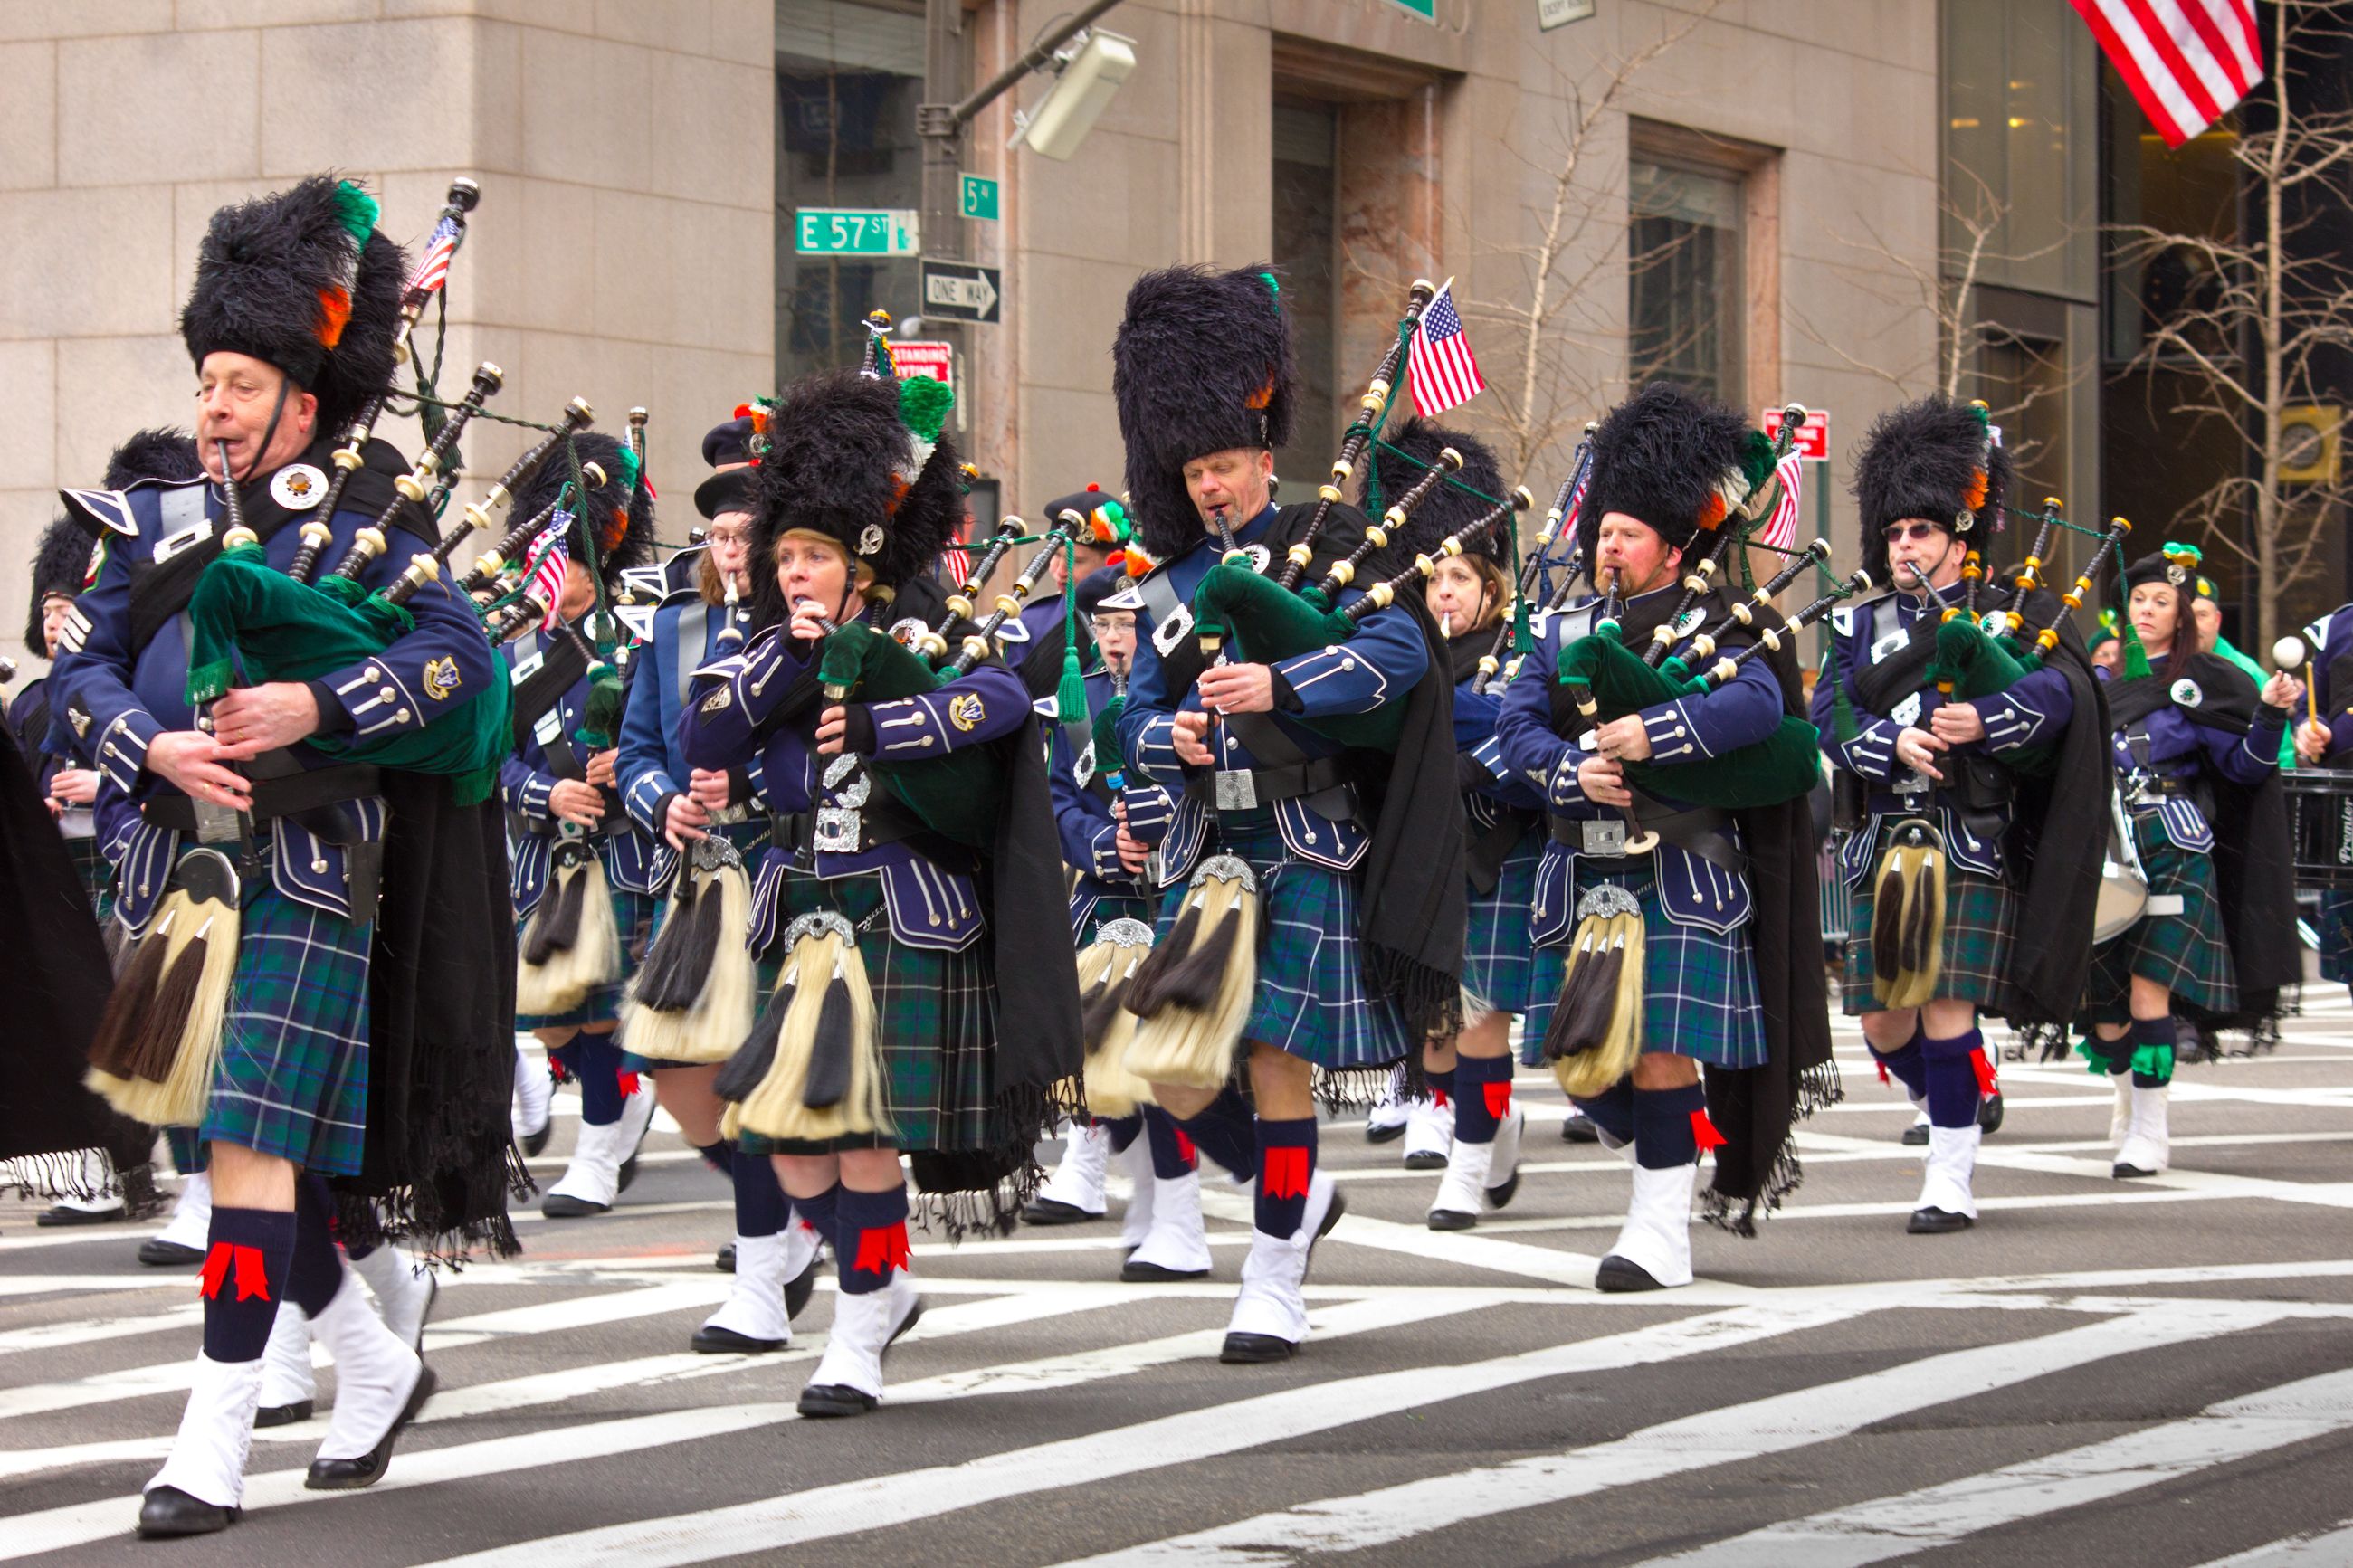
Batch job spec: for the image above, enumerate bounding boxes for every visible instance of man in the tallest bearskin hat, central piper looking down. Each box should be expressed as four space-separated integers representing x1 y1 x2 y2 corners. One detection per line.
1113 268 1462 1364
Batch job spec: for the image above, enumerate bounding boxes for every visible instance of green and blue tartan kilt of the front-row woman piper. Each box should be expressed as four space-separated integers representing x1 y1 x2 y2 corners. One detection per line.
741 872 997 1155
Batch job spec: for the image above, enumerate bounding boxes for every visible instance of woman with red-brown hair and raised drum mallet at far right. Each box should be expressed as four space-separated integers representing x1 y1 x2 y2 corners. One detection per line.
2082 546 2303 1178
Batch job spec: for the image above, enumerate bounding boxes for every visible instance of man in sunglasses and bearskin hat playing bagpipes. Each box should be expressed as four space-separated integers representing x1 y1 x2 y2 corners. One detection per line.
1812 397 2103 1237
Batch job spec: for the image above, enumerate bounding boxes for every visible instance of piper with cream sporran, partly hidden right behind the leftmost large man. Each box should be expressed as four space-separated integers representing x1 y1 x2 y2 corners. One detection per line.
499 432 659 1220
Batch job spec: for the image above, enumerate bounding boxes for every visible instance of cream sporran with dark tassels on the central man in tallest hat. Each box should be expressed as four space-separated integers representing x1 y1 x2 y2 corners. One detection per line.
1125 856 1259 1088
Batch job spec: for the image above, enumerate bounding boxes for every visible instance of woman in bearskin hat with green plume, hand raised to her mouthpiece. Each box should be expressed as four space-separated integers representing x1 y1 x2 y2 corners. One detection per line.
680 372 1078 1415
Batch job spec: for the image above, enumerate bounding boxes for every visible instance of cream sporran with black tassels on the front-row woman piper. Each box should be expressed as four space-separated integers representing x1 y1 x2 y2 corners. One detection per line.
722 912 890 1143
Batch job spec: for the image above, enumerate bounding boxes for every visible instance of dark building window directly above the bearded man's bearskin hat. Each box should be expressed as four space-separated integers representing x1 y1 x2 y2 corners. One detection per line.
1626 157 1748 406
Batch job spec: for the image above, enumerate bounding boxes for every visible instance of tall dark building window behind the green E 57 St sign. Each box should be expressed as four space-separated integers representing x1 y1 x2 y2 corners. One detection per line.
776 0 922 384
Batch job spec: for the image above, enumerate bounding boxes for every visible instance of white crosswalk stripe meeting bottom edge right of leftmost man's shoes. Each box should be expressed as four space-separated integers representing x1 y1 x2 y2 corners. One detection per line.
414 1302 1856 1568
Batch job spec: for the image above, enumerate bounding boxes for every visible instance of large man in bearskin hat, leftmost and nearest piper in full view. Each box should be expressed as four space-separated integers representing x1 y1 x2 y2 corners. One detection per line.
54 178 510 1535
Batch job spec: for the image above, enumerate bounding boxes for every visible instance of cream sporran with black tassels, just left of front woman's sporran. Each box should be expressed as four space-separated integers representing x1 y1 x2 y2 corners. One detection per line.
621 840 760 1062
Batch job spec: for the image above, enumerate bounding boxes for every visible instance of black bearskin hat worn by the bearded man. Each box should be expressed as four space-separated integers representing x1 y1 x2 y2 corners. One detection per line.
1577 381 1772 566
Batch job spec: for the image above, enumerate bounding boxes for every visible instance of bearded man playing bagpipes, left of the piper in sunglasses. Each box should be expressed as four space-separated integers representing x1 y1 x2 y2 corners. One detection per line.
1494 384 1838 1290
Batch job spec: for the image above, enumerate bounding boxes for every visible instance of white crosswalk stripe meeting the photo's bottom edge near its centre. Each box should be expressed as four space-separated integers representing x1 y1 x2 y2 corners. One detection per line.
1063 1302 2273 1568
